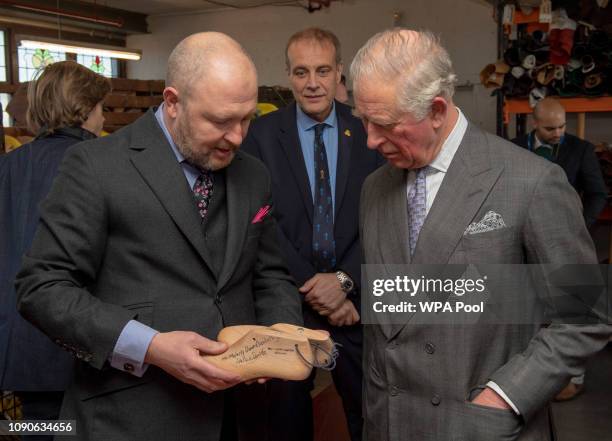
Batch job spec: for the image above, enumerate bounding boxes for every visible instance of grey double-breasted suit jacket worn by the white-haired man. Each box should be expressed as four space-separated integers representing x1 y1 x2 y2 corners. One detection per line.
360 124 610 441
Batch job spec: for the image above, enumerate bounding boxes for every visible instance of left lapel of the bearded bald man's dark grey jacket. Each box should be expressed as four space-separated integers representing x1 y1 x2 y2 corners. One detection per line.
130 110 214 277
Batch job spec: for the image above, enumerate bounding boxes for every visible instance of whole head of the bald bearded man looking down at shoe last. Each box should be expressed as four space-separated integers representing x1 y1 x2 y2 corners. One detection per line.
163 32 257 170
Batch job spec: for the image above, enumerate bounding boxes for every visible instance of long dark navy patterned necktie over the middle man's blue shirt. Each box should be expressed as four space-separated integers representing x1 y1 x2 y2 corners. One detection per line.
312 124 336 272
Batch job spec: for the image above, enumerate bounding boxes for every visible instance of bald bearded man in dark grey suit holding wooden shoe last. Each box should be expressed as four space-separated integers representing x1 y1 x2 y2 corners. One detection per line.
17 33 302 441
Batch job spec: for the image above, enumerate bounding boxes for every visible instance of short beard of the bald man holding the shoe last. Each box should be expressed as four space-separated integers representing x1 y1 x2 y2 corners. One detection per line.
175 115 238 171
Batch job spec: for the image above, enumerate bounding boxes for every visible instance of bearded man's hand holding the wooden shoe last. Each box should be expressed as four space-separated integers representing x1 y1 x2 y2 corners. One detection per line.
145 331 242 393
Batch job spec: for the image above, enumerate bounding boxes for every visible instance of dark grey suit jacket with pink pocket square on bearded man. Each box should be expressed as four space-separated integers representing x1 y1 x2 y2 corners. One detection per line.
17 111 301 441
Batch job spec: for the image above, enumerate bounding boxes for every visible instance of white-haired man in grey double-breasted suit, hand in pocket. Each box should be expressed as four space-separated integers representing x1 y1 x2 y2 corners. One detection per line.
351 29 610 441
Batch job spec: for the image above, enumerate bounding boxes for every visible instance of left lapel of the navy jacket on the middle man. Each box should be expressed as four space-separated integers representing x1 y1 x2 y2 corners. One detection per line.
279 104 313 224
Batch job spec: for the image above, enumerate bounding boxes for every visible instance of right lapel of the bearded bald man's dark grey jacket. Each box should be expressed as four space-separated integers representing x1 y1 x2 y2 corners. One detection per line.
217 152 250 290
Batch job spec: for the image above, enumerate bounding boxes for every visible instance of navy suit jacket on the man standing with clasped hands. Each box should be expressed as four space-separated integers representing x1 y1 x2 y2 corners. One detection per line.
243 102 383 312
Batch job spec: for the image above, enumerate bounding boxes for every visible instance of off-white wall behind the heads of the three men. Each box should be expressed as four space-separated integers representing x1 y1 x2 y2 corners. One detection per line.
127 0 496 131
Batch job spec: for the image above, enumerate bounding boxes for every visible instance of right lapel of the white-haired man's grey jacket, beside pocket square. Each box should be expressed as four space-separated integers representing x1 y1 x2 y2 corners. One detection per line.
389 124 503 338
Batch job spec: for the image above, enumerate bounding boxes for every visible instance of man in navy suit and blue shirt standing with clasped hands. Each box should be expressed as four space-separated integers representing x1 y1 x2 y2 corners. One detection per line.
243 28 382 441
